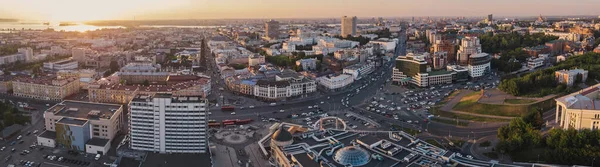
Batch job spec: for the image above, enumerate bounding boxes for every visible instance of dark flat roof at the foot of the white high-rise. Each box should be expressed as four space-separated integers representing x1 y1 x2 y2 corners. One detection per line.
141 152 213 167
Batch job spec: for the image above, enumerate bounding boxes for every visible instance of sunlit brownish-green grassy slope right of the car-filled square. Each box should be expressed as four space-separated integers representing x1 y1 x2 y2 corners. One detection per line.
453 92 529 117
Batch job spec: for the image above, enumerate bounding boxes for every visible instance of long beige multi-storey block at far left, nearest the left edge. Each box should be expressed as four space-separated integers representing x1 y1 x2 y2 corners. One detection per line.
12 75 81 101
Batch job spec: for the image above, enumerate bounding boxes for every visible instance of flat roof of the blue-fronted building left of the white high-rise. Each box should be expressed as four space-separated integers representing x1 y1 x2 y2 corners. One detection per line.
46 100 122 120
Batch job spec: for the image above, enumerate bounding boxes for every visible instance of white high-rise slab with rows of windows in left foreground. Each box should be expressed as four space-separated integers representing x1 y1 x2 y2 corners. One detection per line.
129 94 208 153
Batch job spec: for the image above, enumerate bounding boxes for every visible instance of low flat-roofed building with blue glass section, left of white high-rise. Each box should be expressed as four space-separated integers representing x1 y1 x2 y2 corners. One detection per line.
37 101 123 154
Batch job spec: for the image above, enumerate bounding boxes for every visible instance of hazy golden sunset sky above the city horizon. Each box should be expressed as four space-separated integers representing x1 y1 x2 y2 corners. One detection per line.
0 0 600 21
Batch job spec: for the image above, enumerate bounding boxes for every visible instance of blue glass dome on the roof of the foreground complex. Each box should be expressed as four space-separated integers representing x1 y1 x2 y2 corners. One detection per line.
333 146 371 166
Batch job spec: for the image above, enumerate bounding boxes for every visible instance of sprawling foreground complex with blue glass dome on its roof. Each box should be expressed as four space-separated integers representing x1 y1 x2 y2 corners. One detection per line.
258 119 458 167
